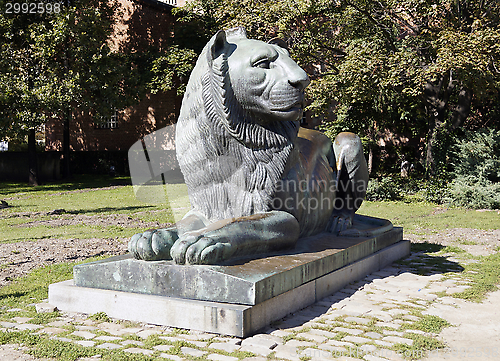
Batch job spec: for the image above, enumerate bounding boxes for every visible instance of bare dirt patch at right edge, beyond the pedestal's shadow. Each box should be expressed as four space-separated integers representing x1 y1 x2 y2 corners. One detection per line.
404 228 500 256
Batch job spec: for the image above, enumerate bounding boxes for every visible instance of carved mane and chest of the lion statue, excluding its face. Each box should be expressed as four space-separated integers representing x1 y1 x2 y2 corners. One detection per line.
176 28 299 221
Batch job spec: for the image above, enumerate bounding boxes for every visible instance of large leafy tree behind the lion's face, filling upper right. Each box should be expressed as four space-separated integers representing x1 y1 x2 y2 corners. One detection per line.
178 0 500 176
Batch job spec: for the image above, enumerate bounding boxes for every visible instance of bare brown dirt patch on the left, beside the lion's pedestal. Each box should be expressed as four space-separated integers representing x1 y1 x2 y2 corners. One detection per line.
0 238 128 287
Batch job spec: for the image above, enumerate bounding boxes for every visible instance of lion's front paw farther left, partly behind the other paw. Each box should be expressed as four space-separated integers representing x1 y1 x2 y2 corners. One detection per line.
128 229 177 261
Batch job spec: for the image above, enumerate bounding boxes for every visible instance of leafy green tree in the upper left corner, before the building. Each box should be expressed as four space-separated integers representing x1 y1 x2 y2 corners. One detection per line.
0 0 140 183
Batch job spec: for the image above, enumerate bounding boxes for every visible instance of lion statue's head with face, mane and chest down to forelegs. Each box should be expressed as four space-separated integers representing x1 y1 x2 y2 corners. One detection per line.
176 28 309 220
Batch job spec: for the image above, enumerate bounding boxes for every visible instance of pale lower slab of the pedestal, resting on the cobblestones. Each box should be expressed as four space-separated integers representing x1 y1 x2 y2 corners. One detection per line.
49 241 410 337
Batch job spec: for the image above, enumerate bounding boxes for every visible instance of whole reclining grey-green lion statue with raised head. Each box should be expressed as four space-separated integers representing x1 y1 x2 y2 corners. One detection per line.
129 28 376 264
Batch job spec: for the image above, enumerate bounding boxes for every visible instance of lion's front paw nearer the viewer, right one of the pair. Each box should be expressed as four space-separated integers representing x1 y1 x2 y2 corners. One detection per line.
170 235 232 264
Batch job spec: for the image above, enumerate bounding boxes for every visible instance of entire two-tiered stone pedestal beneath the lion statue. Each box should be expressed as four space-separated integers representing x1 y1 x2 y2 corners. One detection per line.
49 217 410 337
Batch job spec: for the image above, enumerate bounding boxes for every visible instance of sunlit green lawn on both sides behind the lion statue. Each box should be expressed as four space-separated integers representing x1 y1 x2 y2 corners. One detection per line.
0 176 500 243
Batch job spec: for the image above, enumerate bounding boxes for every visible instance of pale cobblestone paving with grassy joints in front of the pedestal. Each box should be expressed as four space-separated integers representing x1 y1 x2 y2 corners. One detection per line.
0 248 500 361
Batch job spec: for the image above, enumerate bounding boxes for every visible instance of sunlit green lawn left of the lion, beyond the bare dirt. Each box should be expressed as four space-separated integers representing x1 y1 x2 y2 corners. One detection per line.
0 176 189 243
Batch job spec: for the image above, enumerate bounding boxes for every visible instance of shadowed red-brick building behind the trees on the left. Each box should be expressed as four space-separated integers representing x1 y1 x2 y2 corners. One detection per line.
45 0 182 151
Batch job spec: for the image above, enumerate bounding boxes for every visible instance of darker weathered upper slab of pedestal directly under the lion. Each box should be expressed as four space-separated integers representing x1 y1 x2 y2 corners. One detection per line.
73 226 402 305
